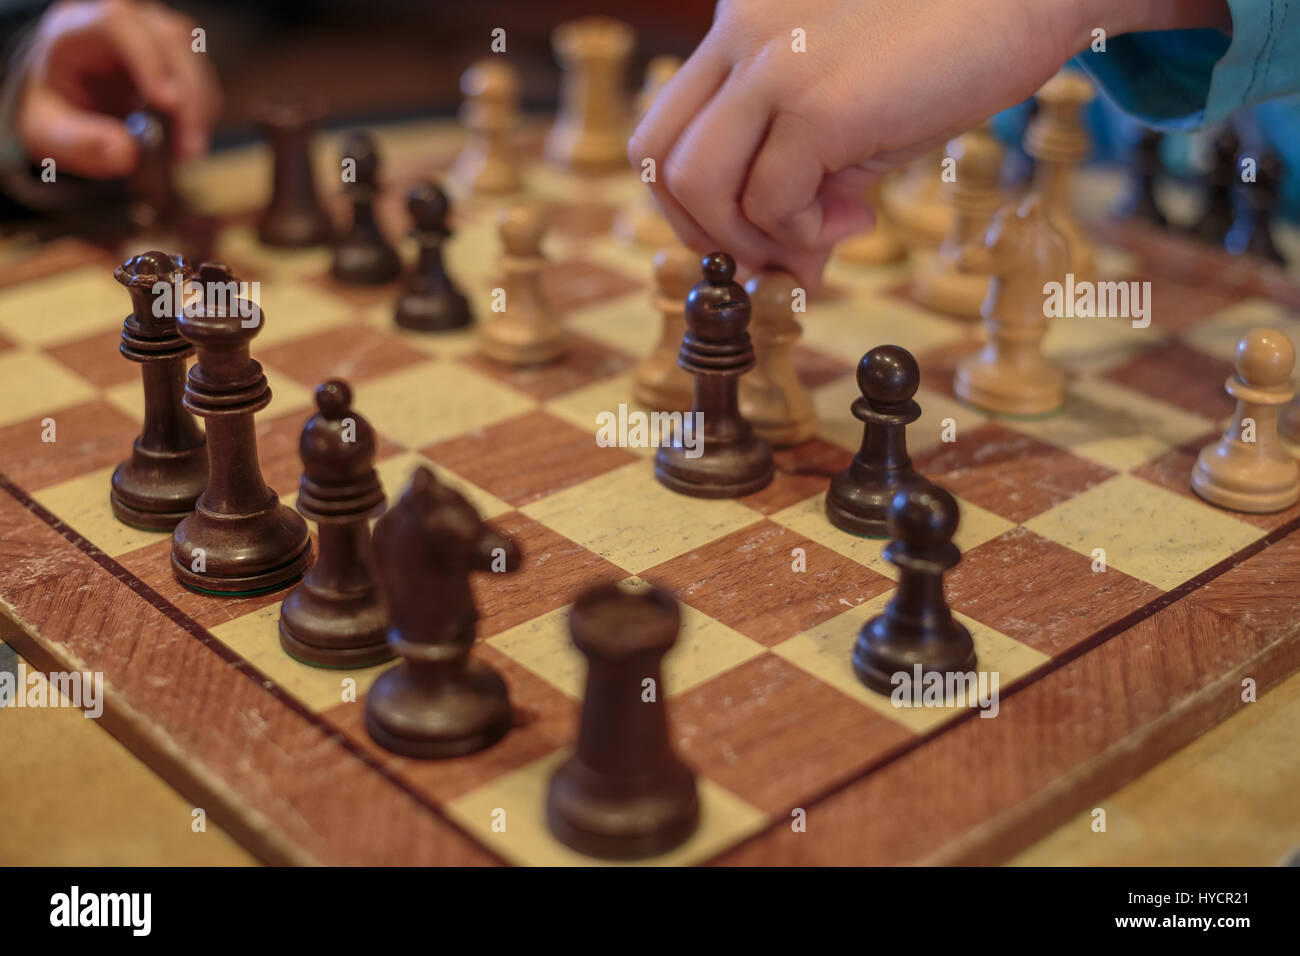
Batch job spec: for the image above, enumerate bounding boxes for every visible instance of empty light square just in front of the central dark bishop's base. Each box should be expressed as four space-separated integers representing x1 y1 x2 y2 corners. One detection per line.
523 462 759 574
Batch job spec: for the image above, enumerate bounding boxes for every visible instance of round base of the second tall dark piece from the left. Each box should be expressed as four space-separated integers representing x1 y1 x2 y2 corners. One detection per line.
172 502 312 596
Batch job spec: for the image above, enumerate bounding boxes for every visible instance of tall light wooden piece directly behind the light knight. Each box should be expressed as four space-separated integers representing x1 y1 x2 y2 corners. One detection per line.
1024 70 1096 281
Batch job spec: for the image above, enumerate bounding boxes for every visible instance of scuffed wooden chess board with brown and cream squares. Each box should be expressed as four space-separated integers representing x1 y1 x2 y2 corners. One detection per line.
0 124 1300 864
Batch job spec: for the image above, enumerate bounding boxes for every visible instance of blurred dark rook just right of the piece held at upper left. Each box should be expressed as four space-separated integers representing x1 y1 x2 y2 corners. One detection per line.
257 98 334 247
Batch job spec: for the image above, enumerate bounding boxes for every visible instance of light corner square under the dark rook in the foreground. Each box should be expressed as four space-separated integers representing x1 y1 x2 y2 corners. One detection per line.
447 749 767 866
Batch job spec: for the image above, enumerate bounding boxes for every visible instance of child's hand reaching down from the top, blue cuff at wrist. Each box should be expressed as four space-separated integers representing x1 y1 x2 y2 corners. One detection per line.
628 0 1222 286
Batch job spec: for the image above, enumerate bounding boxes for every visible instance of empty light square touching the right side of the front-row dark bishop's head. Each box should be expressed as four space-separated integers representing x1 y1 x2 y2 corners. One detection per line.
354 362 536 447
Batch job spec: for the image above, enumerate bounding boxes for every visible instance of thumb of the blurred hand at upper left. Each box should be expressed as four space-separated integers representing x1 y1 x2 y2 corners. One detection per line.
17 95 139 179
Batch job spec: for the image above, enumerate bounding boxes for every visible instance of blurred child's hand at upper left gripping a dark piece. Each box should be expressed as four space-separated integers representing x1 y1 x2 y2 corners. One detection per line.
16 0 221 178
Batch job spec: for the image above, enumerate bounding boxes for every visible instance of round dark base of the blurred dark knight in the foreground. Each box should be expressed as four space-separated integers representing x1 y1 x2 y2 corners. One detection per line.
365 655 514 760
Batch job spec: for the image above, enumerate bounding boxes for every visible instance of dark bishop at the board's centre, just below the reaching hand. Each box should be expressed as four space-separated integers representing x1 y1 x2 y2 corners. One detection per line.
654 252 772 498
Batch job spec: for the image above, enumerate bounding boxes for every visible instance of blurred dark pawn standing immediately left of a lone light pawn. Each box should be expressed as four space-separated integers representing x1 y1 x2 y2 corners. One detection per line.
394 182 473 332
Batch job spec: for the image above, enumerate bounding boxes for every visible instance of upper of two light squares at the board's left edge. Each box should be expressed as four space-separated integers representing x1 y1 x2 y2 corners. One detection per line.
0 265 122 348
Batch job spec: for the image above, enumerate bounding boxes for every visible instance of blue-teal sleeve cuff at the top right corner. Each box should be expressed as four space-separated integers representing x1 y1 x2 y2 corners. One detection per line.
1078 0 1300 130
